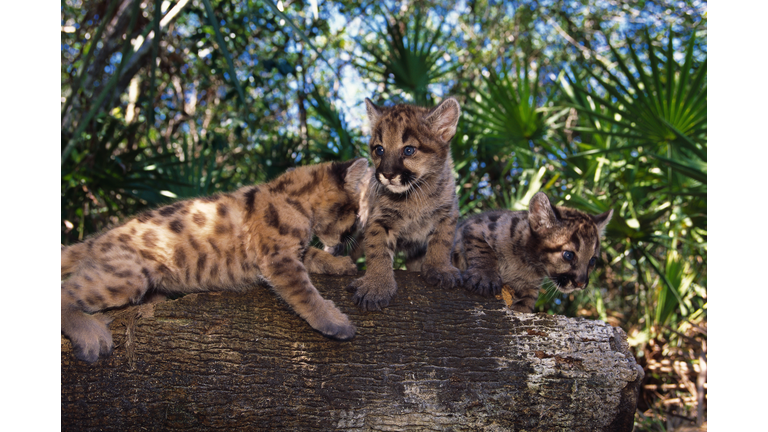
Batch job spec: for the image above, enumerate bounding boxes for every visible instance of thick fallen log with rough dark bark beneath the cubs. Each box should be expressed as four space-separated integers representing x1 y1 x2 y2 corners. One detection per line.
61 272 643 431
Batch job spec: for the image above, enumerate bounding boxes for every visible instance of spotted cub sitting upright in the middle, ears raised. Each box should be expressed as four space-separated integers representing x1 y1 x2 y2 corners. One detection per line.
347 98 461 310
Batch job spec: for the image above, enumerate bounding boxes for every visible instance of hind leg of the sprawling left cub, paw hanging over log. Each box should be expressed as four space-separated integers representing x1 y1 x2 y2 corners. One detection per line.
61 258 150 362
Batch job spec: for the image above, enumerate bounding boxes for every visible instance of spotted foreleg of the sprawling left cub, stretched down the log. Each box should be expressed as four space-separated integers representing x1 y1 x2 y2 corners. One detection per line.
259 255 355 340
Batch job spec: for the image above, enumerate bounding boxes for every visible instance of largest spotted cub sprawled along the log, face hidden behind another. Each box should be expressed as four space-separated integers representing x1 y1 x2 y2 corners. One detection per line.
61 159 368 362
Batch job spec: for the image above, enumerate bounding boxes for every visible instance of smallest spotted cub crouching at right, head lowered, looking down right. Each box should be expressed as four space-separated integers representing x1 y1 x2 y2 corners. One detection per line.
452 192 613 313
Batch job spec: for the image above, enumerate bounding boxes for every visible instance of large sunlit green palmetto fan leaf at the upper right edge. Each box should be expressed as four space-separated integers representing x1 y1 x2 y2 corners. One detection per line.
566 27 707 186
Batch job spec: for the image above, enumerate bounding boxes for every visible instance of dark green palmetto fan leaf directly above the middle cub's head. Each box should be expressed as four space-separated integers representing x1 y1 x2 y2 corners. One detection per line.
357 8 456 105
